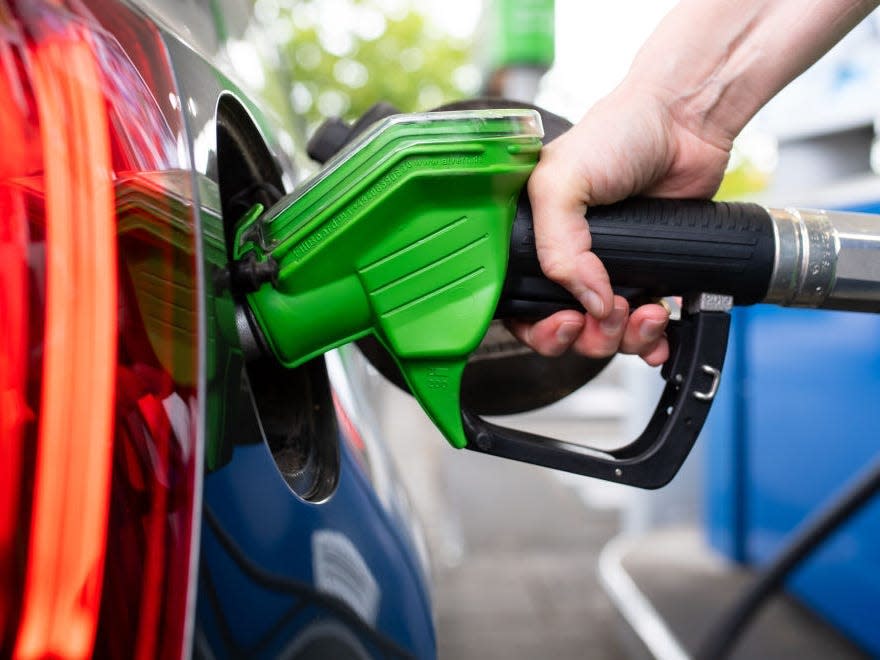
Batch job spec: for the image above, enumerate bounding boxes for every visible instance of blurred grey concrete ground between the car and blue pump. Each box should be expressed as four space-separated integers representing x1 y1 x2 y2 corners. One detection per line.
371 354 864 660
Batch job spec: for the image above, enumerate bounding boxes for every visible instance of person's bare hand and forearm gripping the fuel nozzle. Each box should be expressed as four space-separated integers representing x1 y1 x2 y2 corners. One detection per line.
511 0 880 365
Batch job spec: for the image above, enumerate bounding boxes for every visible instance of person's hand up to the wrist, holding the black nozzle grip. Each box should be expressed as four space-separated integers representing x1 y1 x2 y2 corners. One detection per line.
510 83 732 365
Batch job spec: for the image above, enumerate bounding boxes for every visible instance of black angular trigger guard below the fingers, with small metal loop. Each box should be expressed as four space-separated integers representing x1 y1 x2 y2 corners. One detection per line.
462 294 732 488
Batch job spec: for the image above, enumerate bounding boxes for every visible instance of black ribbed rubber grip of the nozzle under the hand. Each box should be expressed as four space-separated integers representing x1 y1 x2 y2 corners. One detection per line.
496 194 775 318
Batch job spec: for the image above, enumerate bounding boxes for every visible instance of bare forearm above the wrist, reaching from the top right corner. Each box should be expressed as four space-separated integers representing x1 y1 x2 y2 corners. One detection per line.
625 0 880 148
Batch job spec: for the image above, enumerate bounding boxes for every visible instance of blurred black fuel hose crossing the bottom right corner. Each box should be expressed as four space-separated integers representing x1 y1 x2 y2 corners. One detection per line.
694 459 880 660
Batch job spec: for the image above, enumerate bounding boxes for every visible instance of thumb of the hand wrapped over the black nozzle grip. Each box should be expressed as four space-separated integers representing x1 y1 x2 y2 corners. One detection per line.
529 142 613 319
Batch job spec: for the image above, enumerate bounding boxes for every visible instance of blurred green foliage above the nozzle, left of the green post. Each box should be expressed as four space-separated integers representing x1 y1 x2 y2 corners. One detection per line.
257 0 480 132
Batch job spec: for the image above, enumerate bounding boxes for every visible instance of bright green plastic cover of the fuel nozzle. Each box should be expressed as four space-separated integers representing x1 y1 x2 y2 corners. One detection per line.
234 110 542 447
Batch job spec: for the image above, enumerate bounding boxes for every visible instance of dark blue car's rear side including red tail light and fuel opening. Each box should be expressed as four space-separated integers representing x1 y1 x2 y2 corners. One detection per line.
0 0 435 658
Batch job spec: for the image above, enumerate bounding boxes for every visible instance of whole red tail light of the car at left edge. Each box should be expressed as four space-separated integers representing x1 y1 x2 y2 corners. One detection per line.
0 0 199 658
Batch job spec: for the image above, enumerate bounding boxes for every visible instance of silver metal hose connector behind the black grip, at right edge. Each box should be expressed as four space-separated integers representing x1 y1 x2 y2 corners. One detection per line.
765 209 880 312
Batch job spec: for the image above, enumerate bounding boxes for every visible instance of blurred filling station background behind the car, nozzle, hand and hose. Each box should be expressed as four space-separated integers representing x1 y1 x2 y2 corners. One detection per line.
256 0 880 658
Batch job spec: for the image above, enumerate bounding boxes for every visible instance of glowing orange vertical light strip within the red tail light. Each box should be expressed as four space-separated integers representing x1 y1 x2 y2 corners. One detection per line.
14 27 117 658
